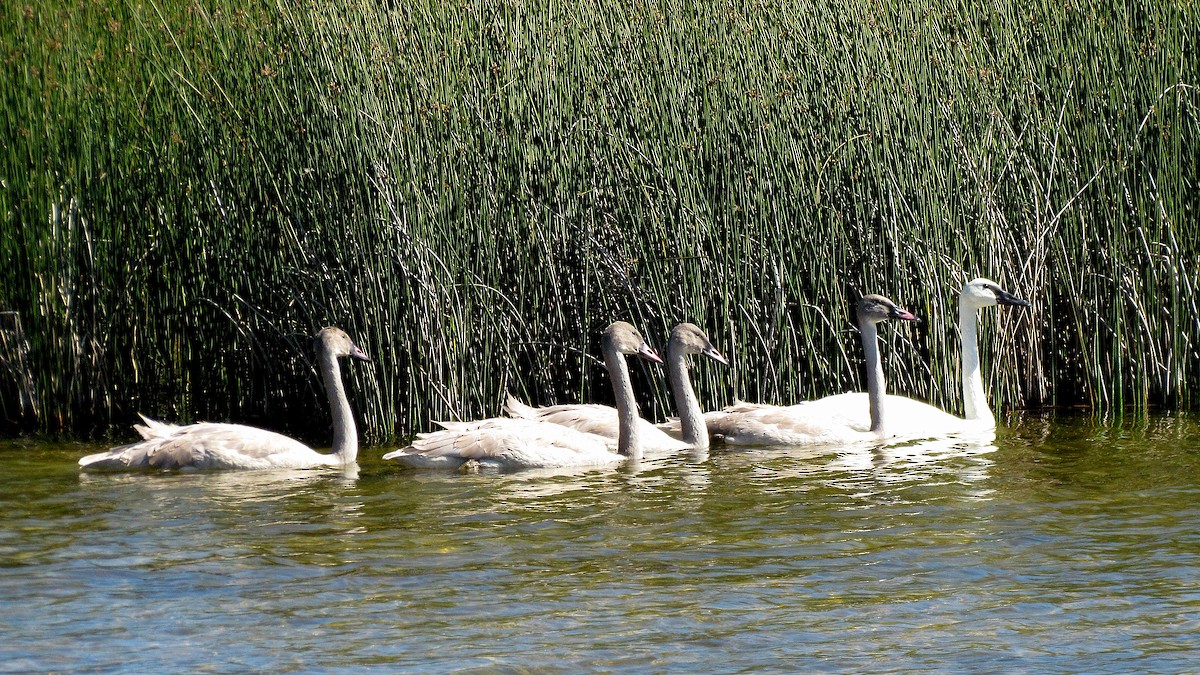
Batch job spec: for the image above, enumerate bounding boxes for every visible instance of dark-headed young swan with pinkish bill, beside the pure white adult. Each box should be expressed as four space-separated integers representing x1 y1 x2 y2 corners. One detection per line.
704 295 917 446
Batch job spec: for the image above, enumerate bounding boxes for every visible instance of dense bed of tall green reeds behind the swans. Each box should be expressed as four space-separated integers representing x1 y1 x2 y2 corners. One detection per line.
0 0 1200 442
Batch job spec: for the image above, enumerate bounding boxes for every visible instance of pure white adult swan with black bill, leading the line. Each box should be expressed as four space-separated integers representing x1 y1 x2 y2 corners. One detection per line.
709 277 1030 442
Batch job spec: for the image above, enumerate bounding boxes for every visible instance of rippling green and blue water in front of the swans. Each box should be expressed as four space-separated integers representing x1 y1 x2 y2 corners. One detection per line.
0 417 1200 673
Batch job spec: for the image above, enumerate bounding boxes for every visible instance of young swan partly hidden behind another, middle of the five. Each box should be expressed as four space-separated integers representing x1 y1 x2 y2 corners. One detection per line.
504 323 728 450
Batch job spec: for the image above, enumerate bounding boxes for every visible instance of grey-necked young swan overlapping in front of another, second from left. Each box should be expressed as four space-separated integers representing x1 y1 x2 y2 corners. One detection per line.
383 321 662 470
